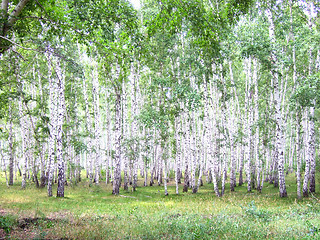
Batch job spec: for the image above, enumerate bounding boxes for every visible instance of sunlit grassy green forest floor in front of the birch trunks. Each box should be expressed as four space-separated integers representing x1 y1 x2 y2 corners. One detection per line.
0 173 320 239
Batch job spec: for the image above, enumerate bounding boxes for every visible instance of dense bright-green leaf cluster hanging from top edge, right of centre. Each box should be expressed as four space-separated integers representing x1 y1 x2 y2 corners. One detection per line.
148 0 252 55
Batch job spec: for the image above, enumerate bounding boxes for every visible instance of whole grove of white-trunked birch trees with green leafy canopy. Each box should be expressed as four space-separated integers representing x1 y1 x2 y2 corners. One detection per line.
0 0 320 198
